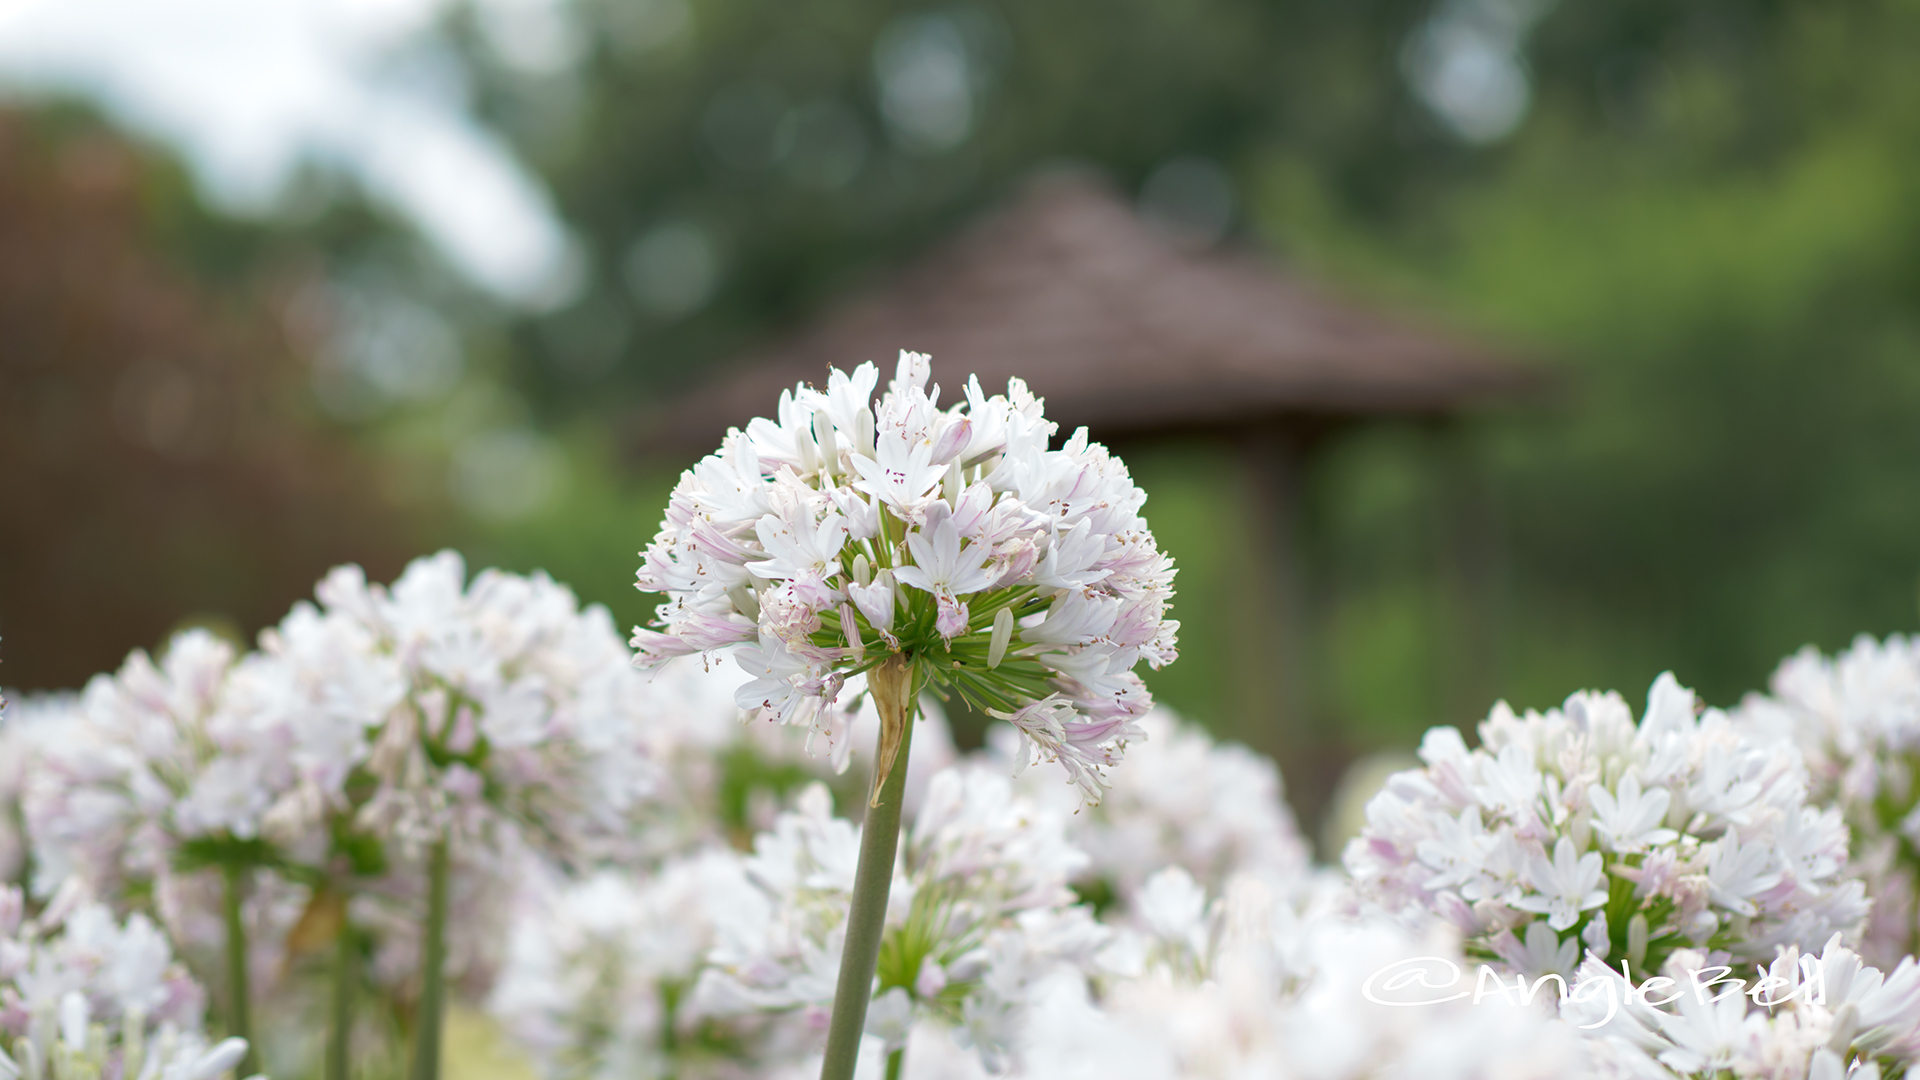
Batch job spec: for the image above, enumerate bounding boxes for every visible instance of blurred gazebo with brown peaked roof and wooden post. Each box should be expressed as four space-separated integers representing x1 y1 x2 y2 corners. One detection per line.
636 177 1540 834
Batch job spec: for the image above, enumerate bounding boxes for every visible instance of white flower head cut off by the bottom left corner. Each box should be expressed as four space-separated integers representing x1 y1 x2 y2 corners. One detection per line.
0 882 246 1080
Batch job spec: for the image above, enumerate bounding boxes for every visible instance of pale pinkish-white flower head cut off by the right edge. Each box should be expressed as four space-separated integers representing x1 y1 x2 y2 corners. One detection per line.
1738 636 1920 965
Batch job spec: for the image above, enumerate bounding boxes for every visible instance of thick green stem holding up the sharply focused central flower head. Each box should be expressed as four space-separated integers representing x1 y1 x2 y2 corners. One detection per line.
820 657 916 1080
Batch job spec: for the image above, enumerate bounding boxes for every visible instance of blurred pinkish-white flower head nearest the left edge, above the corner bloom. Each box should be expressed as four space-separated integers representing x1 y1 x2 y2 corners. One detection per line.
10 630 305 986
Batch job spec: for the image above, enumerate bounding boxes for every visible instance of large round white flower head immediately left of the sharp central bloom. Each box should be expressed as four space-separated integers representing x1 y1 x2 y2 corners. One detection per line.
263 552 657 859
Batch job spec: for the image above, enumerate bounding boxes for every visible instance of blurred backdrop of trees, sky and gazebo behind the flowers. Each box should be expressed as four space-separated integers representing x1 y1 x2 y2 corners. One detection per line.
0 0 1920 845
